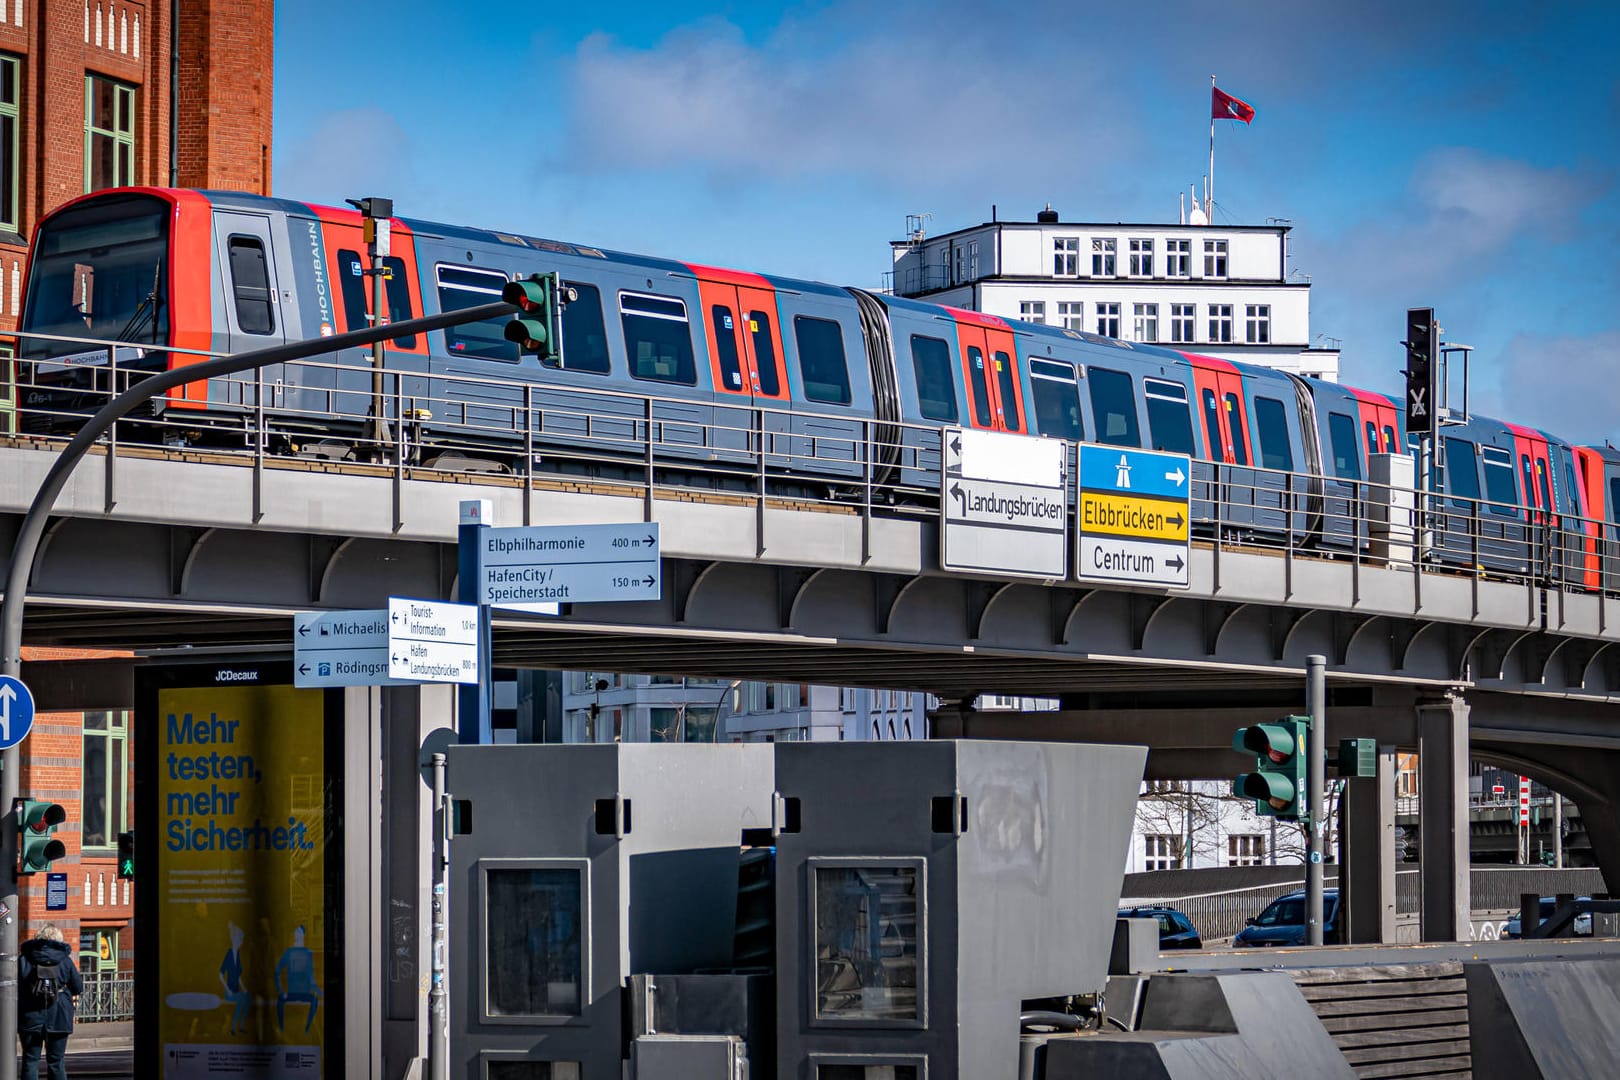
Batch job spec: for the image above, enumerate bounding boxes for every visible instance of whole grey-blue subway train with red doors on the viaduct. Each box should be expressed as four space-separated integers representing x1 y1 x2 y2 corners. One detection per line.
18 188 1620 588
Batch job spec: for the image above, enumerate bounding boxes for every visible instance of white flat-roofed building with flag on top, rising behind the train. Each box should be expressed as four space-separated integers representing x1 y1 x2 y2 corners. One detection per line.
891 206 1338 379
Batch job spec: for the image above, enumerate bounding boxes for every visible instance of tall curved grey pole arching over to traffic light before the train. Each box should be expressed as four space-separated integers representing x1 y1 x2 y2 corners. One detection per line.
0 301 515 1080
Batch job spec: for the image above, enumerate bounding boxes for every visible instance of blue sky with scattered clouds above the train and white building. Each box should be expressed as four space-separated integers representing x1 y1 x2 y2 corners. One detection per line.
274 0 1620 442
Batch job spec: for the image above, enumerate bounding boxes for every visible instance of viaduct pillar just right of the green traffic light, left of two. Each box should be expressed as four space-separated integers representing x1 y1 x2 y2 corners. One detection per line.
1338 743 1395 944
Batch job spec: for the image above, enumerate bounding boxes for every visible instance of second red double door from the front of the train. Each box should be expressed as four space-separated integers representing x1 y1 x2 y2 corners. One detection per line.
692 267 787 402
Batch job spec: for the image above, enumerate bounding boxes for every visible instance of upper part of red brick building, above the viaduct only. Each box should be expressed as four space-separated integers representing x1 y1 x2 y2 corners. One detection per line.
0 0 274 432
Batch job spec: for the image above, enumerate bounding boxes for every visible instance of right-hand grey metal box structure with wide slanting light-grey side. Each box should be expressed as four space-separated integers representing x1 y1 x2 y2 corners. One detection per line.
776 742 1144 1080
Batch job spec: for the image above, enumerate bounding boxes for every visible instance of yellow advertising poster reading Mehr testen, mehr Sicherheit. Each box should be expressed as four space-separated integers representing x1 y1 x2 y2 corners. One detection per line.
156 685 330 1080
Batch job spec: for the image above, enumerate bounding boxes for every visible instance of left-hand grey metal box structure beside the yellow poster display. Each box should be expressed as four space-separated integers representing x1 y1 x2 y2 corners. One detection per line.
447 745 773 1080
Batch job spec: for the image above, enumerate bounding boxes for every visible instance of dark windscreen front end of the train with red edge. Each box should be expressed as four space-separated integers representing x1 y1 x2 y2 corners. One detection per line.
18 188 209 434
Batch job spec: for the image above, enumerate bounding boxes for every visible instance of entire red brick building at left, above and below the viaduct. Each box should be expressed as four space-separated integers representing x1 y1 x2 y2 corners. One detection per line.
0 0 274 1003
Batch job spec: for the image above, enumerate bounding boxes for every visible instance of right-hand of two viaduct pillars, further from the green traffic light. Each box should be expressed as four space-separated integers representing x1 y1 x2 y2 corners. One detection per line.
1418 693 1473 941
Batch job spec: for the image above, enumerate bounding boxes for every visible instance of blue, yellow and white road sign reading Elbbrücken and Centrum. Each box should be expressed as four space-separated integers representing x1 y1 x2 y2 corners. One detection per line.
1074 445 1192 588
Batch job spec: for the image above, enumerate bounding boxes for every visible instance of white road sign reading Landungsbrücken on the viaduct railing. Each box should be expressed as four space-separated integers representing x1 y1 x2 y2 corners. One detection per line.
940 427 1069 581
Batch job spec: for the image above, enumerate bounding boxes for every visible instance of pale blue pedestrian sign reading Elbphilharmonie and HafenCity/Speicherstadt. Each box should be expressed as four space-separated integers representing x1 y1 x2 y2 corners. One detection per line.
478 523 664 612
